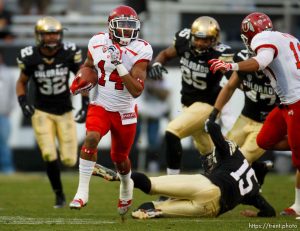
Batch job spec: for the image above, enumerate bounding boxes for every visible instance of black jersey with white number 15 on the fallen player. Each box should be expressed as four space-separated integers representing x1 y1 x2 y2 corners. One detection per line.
207 121 259 215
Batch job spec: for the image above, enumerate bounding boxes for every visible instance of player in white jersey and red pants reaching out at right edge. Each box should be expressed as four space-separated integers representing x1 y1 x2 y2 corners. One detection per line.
209 12 300 215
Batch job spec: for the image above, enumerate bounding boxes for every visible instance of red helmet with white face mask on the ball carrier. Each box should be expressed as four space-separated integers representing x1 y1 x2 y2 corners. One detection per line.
108 6 140 46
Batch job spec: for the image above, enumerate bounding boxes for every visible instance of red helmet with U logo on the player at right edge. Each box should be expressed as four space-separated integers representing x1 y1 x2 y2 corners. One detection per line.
241 12 273 49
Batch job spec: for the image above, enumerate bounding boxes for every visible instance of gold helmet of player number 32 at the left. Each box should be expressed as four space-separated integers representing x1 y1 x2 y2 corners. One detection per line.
35 16 63 49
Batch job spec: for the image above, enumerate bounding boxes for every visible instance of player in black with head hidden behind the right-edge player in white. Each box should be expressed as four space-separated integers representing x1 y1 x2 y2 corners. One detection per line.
210 49 277 184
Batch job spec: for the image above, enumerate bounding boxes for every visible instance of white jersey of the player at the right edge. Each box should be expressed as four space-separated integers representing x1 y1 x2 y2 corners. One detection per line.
251 31 300 104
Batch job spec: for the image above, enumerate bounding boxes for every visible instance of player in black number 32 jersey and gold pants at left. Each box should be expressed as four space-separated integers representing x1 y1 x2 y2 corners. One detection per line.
16 17 89 208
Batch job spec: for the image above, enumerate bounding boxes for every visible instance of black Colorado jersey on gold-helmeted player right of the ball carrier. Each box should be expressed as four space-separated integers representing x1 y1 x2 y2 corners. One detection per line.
174 28 233 106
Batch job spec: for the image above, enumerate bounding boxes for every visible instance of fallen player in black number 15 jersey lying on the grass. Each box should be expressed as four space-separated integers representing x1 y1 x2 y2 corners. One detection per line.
93 120 276 219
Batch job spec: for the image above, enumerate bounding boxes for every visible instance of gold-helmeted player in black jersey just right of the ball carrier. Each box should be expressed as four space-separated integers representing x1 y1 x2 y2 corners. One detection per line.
148 16 233 177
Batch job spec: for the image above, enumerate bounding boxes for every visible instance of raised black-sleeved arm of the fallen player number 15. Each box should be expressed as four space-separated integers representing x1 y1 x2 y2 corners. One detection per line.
206 120 230 158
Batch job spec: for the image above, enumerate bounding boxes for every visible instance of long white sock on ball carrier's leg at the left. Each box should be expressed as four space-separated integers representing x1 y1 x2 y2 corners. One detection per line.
74 158 96 203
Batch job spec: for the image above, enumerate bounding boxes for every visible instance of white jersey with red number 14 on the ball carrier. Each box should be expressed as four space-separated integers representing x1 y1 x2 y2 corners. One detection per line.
88 33 153 112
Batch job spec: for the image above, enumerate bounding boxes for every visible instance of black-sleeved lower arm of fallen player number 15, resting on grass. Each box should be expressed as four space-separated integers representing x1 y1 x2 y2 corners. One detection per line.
242 193 276 217
